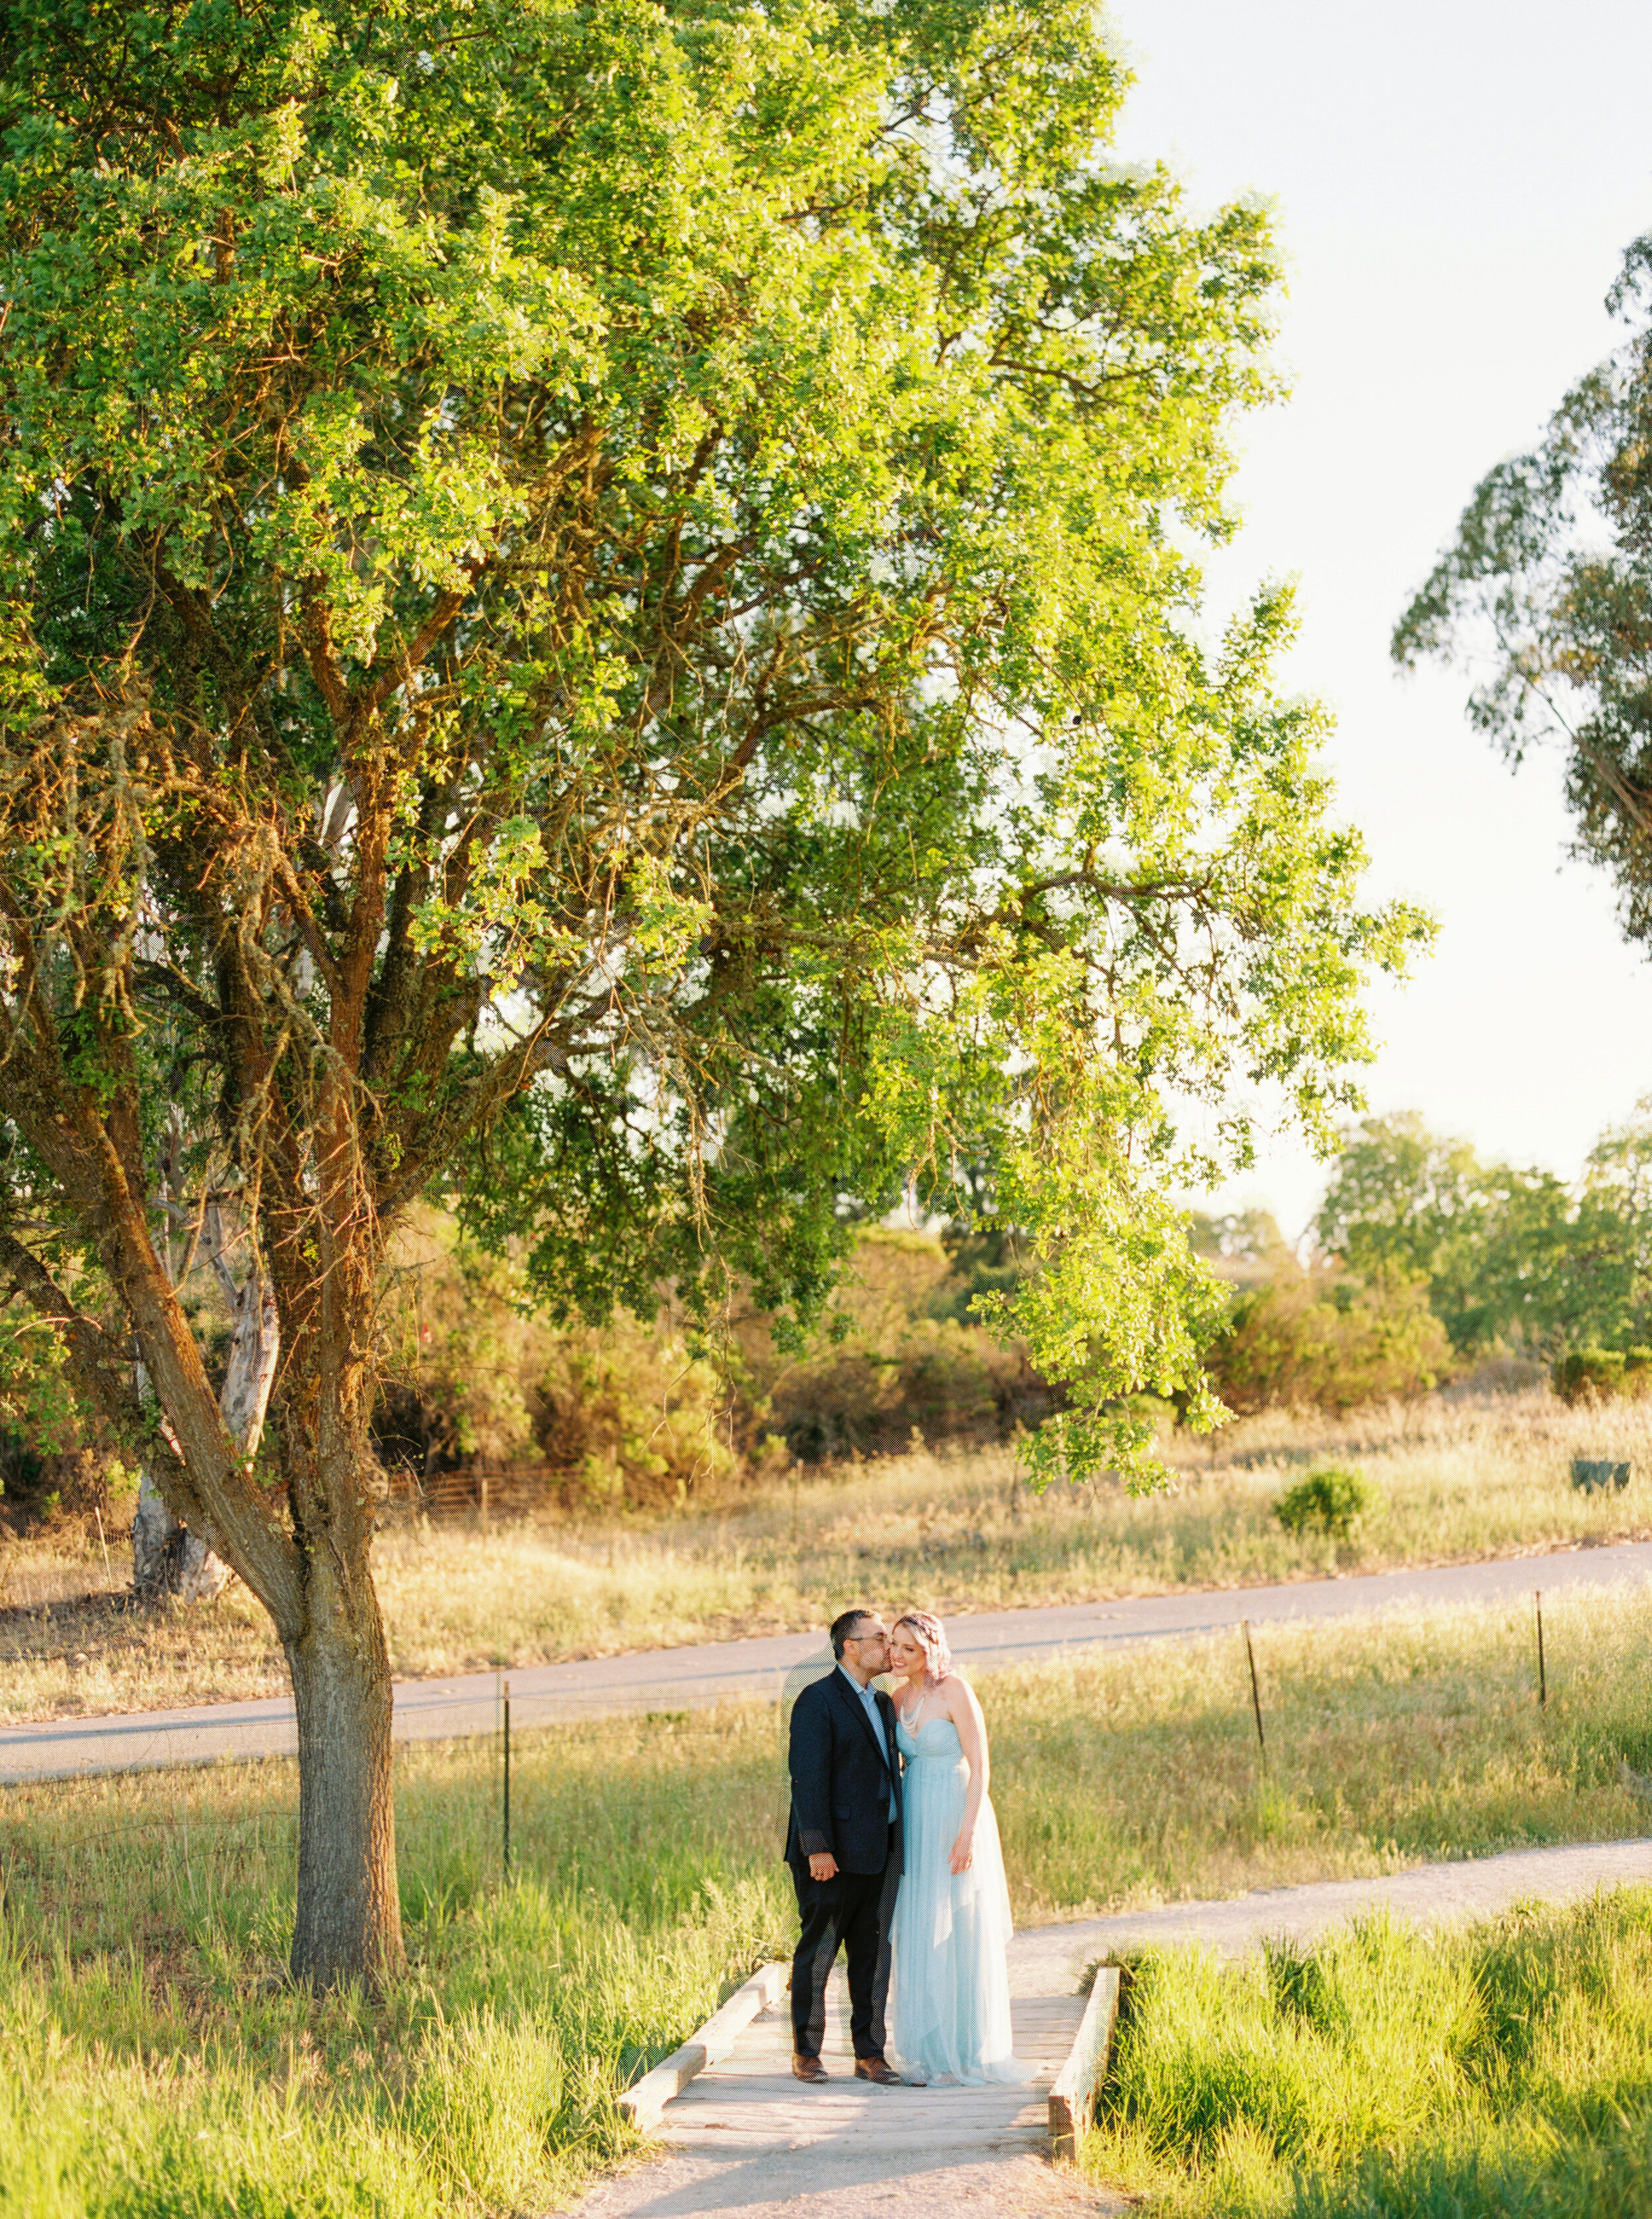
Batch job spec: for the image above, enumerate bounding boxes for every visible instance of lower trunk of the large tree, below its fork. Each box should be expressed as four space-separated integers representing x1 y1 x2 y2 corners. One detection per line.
286 1585 402 1988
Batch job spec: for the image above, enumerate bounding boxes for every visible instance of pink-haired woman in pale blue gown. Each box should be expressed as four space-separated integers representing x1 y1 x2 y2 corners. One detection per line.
888 1611 1033 2086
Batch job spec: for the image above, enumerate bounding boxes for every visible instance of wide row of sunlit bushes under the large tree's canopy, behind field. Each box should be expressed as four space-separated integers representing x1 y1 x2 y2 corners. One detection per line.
373 1211 1055 1511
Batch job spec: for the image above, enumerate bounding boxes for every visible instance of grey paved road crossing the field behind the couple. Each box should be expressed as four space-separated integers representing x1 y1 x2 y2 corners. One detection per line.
0 1542 1652 1784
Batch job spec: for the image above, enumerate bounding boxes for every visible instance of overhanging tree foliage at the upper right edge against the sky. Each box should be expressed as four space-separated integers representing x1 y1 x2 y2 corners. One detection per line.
1392 233 1652 941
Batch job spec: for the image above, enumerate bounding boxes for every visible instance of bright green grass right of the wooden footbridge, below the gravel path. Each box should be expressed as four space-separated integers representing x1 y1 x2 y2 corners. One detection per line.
1081 1889 1652 2219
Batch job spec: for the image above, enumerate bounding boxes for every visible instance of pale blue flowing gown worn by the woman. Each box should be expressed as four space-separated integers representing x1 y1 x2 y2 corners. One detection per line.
888 1717 1033 2088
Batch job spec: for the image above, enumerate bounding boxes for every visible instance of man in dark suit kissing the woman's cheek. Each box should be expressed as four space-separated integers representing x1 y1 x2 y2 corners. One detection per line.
786 1611 901 2086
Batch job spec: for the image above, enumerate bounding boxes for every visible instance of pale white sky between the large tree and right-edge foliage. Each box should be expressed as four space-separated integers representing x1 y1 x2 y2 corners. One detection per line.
1112 0 1652 1234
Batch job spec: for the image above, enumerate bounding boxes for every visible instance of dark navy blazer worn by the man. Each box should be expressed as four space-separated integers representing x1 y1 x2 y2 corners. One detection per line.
786 1665 901 1873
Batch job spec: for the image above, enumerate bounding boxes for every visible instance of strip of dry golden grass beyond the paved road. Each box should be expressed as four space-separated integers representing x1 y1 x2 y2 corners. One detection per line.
0 1394 1652 1719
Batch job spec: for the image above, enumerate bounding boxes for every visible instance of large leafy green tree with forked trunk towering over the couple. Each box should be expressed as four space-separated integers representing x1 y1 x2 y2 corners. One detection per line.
0 0 1421 1979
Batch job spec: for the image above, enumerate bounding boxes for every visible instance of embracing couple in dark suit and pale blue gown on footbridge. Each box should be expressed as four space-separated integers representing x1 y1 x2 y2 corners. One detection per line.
786 1611 1030 2086
